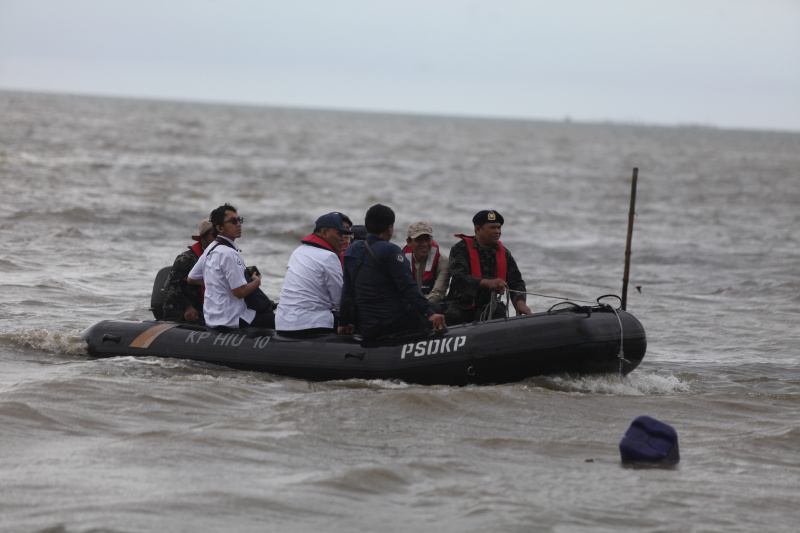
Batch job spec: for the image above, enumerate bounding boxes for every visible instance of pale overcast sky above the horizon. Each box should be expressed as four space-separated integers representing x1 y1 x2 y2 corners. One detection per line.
0 0 800 131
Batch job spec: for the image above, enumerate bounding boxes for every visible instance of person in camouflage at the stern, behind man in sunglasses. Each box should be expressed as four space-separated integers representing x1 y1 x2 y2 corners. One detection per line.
163 220 214 322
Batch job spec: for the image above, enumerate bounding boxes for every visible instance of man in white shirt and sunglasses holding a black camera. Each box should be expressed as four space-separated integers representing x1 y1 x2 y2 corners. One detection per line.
188 204 275 328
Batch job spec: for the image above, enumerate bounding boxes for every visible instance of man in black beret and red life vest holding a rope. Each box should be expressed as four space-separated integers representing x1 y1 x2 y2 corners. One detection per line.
445 210 531 324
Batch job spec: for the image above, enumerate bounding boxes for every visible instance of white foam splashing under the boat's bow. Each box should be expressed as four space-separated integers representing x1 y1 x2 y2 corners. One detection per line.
541 372 692 396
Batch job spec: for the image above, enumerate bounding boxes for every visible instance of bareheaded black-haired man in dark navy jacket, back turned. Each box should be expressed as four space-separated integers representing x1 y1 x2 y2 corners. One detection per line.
340 204 447 339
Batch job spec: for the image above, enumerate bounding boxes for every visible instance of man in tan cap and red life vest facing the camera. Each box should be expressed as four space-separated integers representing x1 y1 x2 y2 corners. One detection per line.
403 221 450 313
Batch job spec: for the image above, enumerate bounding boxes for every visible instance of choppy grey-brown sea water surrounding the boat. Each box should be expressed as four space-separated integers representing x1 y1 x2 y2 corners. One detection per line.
0 92 800 533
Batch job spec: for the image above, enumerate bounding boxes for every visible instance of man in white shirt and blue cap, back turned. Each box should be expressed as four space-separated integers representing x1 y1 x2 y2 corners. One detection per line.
275 212 353 337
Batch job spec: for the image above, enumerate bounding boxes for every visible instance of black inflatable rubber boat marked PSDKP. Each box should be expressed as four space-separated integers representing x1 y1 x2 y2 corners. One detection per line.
82 304 647 385
